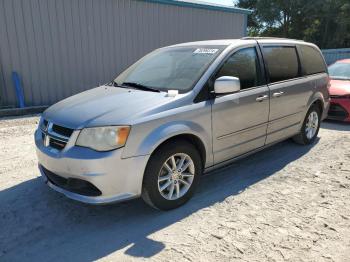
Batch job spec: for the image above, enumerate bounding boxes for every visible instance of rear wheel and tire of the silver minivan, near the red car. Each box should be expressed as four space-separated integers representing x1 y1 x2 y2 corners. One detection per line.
293 104 321 145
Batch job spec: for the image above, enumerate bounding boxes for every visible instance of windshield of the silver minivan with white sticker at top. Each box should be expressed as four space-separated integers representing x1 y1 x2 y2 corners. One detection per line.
114 46 224 93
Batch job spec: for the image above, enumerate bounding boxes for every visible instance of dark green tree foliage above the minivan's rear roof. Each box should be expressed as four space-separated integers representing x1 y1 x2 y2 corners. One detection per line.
237 0 350 48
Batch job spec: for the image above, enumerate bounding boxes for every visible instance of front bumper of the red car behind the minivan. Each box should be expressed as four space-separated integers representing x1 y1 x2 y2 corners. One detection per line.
327 98 350 122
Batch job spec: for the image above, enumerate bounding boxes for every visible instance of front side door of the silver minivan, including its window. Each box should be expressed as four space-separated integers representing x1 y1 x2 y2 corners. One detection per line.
212 46 269 164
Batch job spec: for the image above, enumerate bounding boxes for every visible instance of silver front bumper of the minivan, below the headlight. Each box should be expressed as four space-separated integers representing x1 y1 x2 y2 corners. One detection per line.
35 130 149 204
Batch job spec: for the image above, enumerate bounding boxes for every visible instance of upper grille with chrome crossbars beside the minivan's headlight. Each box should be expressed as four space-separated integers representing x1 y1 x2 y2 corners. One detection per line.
40 119 74 150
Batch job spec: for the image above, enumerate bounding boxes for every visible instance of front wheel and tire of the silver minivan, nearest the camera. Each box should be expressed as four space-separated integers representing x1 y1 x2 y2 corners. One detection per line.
142 140 203 210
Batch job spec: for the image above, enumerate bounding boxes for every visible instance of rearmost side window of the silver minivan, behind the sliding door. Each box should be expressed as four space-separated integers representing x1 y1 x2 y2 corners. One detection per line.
300 45 327 75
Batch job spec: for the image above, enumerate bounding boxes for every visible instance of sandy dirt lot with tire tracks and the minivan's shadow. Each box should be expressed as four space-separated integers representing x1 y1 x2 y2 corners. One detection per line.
0 117 350 261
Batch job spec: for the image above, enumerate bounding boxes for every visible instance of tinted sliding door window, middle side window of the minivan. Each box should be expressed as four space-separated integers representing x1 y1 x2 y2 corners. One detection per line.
263 46 299 83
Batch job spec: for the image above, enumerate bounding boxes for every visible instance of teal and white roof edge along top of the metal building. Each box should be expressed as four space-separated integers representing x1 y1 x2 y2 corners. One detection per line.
141 0 253 15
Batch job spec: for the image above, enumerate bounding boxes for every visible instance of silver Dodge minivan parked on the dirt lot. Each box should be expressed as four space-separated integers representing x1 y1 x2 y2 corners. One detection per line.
35 38 329 210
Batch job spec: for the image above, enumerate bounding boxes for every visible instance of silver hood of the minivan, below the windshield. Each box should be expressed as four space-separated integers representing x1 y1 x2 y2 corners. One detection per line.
43 86 182 129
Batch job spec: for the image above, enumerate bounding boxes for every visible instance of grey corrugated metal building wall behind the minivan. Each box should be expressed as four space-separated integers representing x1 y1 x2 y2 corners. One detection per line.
0 0 250 109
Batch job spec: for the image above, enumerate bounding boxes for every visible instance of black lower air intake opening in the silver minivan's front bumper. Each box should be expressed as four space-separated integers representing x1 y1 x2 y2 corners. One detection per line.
40 166 102 196
